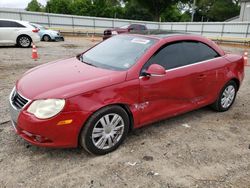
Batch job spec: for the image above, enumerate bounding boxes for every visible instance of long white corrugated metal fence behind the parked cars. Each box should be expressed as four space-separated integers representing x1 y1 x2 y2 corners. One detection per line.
0 8 250 39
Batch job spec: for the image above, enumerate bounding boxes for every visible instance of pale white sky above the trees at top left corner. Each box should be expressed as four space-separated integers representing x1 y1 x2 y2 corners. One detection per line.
0 0 47 9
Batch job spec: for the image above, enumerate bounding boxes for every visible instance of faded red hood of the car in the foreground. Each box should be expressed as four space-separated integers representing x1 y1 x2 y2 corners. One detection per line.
16 58 126 100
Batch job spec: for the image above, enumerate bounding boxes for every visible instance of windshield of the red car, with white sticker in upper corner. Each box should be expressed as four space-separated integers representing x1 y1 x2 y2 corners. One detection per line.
80 35 156 70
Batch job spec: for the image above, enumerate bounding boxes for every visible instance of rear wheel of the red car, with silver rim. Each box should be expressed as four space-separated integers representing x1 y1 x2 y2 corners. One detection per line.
212 80 238 112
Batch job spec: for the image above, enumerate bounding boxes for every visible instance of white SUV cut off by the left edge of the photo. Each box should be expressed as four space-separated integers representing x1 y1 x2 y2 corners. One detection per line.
0 19 40 48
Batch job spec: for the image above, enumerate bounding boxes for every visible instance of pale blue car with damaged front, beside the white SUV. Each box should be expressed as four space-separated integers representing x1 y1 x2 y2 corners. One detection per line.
31 23 64 42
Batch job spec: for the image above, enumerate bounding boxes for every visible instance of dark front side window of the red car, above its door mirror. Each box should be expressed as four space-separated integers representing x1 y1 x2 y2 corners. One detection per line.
143 42 185 70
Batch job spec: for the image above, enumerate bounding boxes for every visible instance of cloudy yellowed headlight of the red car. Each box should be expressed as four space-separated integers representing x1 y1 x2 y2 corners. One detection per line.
27 99 65 119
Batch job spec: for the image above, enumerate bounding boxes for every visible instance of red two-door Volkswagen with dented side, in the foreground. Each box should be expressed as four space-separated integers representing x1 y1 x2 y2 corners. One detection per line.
9 34 244 154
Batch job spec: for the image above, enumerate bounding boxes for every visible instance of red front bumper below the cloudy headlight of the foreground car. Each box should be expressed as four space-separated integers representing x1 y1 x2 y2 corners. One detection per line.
9 90 89 148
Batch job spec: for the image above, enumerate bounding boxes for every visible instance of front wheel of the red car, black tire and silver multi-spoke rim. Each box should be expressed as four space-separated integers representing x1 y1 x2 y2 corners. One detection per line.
79 105 130 155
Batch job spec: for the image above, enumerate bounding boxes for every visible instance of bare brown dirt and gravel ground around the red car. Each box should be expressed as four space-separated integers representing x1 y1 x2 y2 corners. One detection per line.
0 37 250 188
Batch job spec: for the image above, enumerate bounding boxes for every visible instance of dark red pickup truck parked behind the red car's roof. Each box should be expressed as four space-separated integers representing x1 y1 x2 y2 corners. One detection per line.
103 24 148 40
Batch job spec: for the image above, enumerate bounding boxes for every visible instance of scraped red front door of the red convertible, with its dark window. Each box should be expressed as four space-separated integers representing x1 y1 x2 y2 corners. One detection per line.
140 41 219 124
